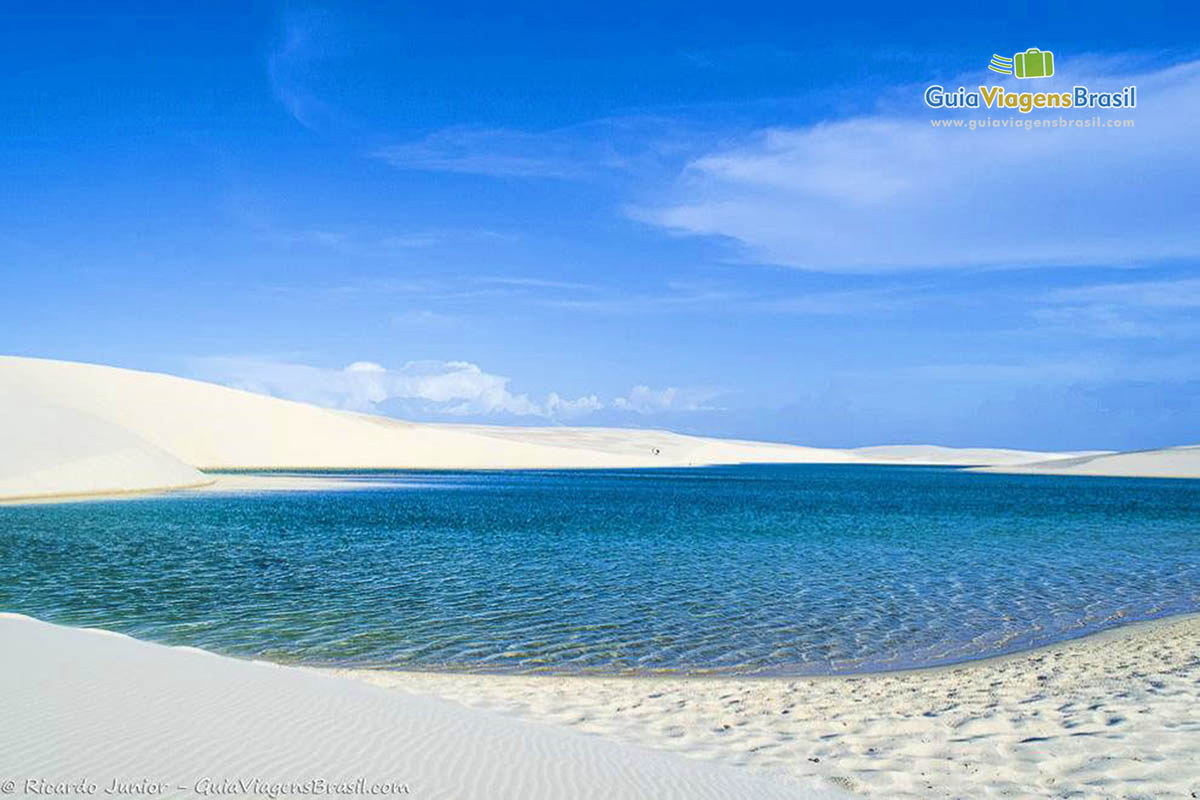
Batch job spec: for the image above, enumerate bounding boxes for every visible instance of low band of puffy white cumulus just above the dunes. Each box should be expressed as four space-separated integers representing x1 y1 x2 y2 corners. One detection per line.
192 357 700 421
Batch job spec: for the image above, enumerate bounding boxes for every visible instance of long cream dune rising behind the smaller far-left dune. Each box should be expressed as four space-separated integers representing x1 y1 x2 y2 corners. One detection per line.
0 357 859 484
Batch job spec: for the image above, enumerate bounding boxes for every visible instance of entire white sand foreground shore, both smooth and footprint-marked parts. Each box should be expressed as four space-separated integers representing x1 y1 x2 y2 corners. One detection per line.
0 614 1200 800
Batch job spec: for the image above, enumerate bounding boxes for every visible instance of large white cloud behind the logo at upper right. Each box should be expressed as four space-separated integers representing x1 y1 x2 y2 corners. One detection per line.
631 60 1200 272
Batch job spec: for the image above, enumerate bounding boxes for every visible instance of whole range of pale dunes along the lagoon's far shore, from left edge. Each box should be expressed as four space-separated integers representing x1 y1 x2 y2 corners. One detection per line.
0 356 1171 499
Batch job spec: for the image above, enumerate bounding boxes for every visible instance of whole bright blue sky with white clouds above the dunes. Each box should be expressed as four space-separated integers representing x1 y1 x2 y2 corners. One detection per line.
0 2 1200 449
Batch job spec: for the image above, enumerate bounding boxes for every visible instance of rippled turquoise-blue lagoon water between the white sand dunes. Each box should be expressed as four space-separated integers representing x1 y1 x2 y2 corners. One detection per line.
0 465 1200 674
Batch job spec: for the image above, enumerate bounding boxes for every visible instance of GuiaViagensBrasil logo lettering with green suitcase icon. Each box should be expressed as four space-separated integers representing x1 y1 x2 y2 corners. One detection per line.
925 47 1138 113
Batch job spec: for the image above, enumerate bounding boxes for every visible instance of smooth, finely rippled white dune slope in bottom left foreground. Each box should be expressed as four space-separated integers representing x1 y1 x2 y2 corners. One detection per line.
0 614 851 800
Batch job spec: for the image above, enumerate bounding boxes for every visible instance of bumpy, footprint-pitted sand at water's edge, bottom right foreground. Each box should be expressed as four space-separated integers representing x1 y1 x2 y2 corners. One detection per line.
346 615 1200 798
